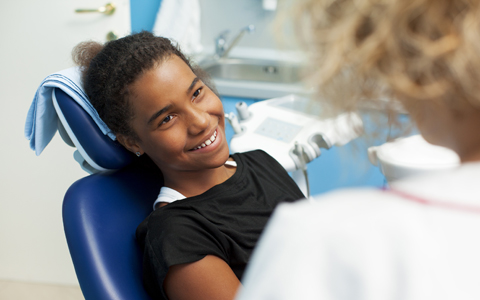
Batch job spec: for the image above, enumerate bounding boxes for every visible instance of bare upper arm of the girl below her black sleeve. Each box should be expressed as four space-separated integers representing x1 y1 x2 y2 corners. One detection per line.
163 255 240 300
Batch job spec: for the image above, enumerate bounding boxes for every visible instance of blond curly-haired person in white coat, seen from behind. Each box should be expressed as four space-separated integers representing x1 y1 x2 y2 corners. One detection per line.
237 0 480 300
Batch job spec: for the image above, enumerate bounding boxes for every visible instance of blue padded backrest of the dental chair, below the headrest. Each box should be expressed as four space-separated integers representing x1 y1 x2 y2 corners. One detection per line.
63 166 162 300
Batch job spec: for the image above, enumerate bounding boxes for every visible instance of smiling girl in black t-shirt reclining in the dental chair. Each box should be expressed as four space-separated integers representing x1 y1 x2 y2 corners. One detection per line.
73 32 304 299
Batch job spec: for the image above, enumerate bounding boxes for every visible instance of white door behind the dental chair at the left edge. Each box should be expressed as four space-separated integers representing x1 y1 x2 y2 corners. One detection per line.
0 0 130 284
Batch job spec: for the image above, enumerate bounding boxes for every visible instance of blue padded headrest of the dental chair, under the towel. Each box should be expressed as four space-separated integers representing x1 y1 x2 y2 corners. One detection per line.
52 88 135 173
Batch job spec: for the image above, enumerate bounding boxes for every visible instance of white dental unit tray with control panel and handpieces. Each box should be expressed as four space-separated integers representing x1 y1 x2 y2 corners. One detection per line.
230 95 362 197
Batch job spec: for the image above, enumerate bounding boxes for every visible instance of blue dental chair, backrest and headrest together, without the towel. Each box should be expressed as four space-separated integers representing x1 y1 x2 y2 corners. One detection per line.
52 89 163 300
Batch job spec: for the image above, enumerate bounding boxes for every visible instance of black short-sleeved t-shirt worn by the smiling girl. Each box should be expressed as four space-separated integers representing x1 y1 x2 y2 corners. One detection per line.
137 150 304 299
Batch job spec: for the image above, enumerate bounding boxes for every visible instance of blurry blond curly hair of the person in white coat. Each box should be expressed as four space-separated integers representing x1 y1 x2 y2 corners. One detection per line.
280 0 480 117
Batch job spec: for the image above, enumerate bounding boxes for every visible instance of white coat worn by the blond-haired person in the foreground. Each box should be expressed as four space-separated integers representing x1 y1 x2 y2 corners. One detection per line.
237 163 480 300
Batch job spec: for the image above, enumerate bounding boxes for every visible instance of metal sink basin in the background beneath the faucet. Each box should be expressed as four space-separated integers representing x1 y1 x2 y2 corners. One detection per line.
199 58 306 99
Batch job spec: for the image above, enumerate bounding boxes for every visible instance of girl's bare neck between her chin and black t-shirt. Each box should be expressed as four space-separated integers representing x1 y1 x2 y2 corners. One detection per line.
164 158 236 198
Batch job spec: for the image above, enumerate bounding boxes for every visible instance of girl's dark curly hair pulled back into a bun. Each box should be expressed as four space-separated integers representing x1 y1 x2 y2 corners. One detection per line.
72 31 216 139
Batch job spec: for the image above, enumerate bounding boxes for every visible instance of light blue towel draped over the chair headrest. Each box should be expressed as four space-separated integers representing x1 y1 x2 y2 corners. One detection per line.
25 67 116 155
